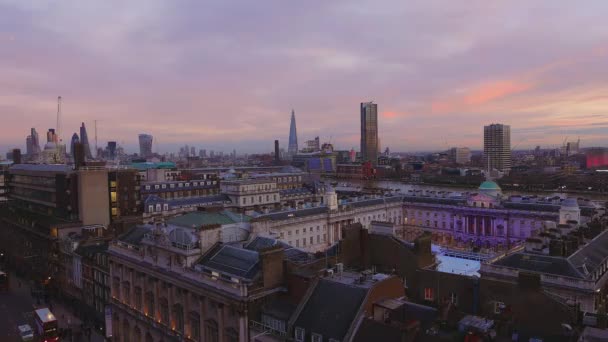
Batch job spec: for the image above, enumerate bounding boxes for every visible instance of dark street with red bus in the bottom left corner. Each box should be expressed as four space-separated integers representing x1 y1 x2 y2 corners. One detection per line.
0 273 105 342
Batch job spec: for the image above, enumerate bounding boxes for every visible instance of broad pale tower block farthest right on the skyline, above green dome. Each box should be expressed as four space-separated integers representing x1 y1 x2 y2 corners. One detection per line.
483 124 511 171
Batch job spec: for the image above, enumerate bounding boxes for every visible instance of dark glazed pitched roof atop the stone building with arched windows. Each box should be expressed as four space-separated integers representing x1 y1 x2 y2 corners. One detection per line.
199 245 260 280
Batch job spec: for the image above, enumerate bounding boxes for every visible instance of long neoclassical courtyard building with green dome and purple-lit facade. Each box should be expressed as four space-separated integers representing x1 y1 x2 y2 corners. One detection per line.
251 181 593 252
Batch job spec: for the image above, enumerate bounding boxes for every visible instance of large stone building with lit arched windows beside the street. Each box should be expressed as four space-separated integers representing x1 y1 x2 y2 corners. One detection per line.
108 213 284 342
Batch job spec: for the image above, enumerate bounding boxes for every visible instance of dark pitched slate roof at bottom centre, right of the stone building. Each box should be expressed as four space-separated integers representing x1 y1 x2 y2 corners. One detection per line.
294 279 367 341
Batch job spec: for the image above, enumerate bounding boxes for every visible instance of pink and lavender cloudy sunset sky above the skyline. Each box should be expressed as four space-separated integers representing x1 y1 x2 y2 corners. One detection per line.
0 0 608 153
